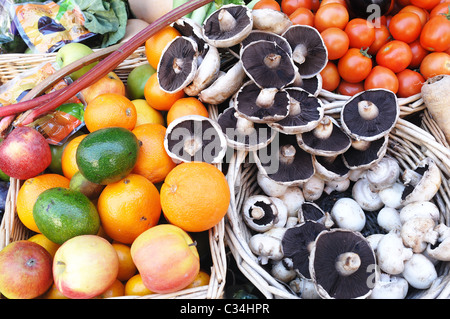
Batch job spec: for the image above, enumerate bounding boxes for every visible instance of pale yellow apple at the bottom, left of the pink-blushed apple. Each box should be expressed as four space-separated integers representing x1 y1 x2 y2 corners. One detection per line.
53 235 119 299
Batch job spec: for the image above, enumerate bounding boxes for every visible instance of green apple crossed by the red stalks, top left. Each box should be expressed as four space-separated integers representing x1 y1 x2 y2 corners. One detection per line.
55 42 98 81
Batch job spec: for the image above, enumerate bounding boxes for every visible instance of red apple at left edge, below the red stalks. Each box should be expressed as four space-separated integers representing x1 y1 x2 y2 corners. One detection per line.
0 126 52 180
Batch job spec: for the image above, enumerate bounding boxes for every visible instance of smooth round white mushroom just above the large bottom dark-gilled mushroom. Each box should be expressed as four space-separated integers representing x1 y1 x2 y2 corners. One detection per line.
330 197 366 231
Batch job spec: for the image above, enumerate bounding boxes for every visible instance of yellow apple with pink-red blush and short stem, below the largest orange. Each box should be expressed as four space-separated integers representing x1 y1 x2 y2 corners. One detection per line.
131 224 200 293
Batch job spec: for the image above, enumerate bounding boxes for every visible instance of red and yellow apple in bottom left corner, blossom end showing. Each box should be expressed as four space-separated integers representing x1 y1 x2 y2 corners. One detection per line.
0 240 53 299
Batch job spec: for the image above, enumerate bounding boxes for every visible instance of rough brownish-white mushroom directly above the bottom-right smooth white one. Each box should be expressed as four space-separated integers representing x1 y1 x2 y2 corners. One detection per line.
400 217 439 253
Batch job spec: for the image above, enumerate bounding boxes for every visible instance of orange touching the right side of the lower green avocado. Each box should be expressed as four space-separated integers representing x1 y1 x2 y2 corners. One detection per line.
97 174 161 244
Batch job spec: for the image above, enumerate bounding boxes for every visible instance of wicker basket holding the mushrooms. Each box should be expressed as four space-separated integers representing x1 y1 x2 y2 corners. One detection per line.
225 91 450 299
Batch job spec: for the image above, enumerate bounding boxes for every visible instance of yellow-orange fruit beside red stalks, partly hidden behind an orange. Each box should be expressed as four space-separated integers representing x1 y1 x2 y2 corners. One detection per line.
81 71 126 104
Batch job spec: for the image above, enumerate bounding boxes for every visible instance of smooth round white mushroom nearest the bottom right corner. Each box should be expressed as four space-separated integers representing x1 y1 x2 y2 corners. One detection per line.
402 254 437 289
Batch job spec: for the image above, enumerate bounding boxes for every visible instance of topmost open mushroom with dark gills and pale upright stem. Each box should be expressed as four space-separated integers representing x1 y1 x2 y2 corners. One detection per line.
202 4 253 48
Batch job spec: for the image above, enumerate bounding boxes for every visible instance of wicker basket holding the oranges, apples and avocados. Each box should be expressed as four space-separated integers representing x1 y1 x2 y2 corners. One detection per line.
0 46 227 299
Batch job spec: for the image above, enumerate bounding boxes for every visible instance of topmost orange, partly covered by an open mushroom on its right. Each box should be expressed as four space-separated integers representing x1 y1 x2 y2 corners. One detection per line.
145 26 181 70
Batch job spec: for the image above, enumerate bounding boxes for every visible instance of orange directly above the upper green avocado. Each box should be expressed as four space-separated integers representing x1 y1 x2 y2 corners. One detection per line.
84 93 137 132
